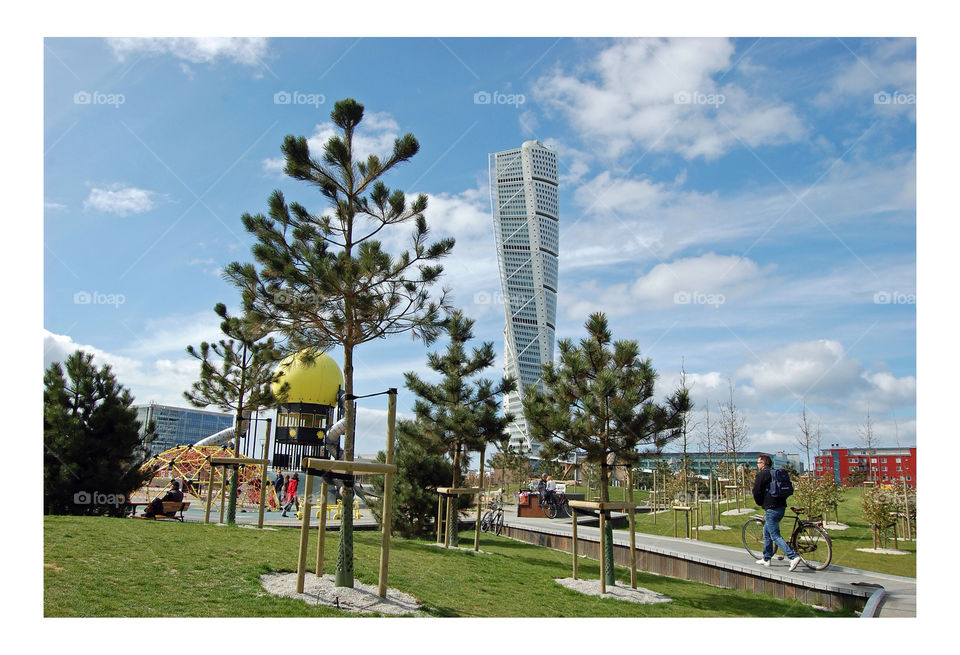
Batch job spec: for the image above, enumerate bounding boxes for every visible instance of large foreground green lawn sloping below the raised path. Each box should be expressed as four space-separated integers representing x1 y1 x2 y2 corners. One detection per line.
44 516 853 617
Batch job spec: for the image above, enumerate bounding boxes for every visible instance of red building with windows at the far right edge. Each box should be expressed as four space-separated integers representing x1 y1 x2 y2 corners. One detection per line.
814 445 917 488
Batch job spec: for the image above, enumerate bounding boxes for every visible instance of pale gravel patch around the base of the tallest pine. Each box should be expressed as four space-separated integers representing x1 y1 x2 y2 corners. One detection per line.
260 572 420 616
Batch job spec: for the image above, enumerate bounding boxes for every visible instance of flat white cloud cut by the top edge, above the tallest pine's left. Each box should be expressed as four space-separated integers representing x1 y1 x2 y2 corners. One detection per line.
107 37 267 72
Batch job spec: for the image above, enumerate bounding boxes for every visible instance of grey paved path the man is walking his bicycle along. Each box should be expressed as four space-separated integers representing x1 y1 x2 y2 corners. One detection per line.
504 507 917 618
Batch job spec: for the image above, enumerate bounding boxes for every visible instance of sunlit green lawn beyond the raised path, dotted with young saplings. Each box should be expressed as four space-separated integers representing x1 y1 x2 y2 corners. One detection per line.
611 489 917 578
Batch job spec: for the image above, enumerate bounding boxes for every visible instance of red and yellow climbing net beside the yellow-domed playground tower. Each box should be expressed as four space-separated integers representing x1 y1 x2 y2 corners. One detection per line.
138 446 280 509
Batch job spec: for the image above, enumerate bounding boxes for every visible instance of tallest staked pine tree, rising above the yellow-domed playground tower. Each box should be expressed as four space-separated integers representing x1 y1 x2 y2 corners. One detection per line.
225 98 454 587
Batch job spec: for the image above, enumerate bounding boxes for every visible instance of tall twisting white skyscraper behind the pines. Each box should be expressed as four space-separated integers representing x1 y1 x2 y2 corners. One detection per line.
490 141 560 455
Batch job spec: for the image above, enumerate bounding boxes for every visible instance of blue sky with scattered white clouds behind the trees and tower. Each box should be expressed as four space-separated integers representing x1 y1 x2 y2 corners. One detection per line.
43 38 917 462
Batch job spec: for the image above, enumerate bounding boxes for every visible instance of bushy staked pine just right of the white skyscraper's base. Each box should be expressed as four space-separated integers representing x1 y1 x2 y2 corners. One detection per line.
523 313 690 584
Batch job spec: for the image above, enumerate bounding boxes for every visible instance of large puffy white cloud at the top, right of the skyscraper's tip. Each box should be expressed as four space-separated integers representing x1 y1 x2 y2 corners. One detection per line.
533 38 805 159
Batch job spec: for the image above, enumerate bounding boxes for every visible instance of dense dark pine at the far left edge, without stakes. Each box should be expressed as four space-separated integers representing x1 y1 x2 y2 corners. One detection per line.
43 350 154 516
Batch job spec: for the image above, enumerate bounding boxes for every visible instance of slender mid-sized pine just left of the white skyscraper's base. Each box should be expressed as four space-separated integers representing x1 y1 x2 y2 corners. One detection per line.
400 310 516 545
